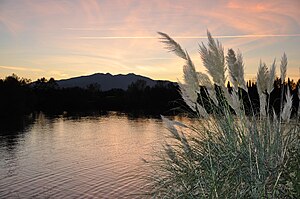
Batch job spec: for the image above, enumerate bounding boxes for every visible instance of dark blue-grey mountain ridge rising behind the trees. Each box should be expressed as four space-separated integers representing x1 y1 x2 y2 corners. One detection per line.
57 73 157 91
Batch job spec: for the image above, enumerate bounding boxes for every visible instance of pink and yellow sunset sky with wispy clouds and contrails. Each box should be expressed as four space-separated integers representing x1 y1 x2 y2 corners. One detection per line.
0 0 300 81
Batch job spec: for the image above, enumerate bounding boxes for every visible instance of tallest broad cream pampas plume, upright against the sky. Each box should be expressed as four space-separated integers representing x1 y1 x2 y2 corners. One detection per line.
199 31 226 86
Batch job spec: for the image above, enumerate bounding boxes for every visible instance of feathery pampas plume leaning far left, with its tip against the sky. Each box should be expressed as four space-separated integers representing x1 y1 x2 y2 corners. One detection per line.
157 32 187 60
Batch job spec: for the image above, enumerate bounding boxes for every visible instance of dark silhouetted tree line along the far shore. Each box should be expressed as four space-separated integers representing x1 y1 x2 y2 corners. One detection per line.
0 74 300 117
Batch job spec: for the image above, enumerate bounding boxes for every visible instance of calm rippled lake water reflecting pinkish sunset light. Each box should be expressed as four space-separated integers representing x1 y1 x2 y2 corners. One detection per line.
0 113 166 198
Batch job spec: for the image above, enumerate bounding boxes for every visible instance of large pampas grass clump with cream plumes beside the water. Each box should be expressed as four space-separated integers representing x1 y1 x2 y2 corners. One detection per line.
148 32 300 198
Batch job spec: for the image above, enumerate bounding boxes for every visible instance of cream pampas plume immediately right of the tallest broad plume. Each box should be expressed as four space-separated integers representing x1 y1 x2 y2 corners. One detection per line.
226 49 248 91
